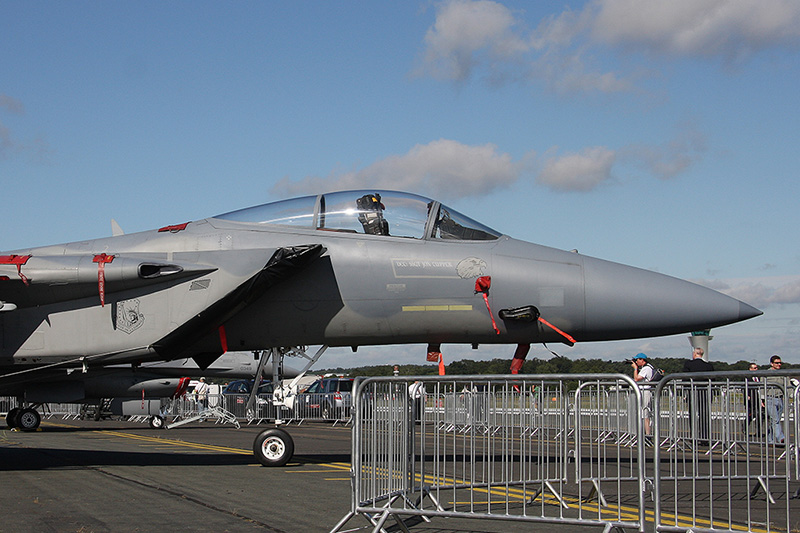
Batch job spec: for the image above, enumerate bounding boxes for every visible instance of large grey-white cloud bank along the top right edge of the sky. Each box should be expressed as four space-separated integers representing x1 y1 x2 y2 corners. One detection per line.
416 0 800 93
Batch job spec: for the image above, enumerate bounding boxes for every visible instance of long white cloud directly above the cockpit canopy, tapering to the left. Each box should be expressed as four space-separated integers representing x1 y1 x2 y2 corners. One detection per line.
273 139 522 199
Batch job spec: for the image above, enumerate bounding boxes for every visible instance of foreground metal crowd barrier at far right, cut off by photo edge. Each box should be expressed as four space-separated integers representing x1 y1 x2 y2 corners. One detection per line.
653 370 800 532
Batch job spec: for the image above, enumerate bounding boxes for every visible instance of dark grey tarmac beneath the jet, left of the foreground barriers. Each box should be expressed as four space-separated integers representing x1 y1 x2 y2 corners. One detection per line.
0 418 598 533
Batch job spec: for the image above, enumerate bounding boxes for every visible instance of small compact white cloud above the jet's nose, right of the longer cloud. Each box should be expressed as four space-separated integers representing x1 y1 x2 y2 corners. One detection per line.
536 146 616 191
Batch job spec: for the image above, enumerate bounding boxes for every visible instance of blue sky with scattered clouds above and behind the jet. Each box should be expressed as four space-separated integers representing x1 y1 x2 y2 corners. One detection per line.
0 0 800 366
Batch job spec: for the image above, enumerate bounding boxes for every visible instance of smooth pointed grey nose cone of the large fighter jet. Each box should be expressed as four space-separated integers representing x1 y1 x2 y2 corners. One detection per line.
579 257 762 340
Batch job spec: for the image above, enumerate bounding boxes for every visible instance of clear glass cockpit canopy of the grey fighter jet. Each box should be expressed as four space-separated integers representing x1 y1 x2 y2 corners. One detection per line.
214 190 500 241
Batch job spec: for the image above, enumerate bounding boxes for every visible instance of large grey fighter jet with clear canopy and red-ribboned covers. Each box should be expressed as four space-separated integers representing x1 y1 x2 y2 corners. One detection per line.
0 190 761 464
